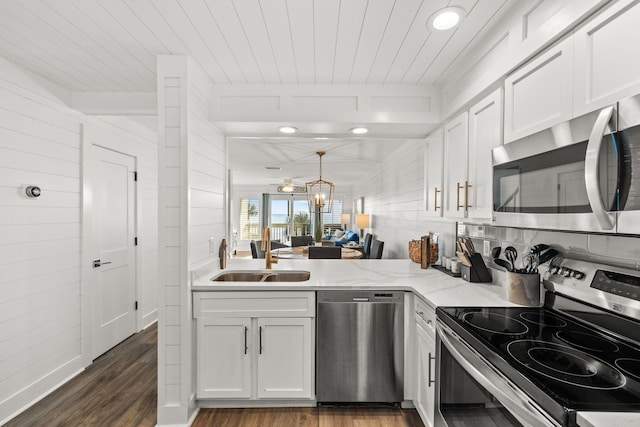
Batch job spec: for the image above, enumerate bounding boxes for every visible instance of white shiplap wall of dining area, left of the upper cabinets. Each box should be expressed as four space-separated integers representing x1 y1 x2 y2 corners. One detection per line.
354 141 455 258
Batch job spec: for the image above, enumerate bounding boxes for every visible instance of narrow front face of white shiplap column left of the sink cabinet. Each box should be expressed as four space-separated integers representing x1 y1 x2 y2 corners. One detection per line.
157 56 195 425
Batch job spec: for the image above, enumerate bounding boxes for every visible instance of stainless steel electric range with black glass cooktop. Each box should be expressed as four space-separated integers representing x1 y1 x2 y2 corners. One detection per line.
436 259 640 426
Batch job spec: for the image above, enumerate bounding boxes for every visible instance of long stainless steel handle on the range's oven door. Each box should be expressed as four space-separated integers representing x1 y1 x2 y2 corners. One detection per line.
436 321 560 427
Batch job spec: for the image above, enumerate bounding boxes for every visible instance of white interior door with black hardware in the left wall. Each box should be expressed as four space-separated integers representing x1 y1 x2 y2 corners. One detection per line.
91 146 136 358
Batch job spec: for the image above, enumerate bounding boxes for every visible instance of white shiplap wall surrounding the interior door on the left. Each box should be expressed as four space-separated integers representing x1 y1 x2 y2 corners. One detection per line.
0 58 157 424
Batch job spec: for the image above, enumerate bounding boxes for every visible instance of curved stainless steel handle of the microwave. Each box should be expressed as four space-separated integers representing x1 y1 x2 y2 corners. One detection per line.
584 107 615 230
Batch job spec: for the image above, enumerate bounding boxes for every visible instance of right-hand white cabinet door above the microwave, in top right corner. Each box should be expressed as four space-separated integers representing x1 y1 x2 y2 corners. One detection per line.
574 0 640 115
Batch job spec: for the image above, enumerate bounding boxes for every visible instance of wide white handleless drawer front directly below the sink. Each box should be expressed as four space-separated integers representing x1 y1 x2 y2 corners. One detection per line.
193 291 316 318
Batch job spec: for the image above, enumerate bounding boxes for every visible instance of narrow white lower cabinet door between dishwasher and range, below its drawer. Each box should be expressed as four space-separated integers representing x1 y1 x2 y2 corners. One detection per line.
414 322 436 426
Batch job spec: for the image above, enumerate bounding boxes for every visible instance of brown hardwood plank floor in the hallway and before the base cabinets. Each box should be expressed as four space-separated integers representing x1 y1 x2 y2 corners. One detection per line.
5 324 423 427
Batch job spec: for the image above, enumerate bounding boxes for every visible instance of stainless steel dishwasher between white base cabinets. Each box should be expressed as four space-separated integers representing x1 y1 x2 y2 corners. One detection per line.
316 291 404 403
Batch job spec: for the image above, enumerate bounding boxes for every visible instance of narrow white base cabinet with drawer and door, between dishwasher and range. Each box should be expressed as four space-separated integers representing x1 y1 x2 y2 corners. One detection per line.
413 299 436 427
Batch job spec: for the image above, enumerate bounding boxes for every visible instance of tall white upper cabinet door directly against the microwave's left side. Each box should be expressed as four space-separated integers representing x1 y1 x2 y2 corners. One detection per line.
465 89 502 219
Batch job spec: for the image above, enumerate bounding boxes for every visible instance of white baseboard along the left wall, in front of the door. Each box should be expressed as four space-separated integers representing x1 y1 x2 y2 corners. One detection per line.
0 355 86 425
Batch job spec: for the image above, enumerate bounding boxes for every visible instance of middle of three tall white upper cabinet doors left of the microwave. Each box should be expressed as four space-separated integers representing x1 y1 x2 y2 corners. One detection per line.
444 112 469 218
